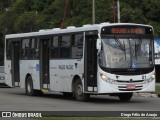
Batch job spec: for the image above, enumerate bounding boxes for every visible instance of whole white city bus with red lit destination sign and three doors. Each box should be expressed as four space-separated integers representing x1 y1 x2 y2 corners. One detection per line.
5 23 155 101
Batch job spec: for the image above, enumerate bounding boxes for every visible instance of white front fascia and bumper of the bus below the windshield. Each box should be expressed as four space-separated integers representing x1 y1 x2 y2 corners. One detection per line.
97 67 155 93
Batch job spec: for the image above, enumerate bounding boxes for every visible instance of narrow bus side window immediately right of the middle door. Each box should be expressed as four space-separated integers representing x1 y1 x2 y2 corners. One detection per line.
51 36 59 58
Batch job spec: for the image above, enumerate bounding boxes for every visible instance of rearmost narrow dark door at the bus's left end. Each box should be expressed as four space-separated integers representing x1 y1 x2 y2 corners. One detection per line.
11 41 20 87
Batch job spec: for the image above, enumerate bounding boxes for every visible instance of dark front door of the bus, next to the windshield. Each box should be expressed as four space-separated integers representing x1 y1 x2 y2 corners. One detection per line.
84 34 97 92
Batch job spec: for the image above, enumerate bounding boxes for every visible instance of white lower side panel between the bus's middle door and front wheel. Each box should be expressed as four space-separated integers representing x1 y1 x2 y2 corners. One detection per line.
50 59 84 92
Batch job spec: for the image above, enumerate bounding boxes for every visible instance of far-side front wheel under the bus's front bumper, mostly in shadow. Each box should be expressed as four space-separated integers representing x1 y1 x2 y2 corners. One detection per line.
118 93 133 102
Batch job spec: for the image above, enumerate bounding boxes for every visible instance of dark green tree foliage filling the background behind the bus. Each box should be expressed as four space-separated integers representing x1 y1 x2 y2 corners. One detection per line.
0 0 160 65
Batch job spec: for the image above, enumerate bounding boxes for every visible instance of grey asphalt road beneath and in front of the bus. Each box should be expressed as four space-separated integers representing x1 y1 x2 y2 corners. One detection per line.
0 85 160 111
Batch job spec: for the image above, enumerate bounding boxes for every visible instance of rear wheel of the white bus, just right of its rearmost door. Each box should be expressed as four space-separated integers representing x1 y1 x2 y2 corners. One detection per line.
26 76 43 96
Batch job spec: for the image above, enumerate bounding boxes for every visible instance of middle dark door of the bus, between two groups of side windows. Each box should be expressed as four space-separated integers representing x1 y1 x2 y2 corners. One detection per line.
40 38 50 89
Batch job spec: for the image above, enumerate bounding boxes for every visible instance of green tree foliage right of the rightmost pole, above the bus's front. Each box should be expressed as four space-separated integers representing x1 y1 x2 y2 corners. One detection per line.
121 0 160 37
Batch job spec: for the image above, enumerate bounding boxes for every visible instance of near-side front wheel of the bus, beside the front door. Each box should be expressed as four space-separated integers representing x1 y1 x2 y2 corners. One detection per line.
74 80 90 101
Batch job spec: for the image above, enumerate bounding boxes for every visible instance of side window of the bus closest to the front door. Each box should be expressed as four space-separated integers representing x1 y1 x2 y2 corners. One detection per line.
72 34 83 59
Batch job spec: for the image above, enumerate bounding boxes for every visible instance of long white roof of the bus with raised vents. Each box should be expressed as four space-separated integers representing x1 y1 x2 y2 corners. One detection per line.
5 23 152 39
